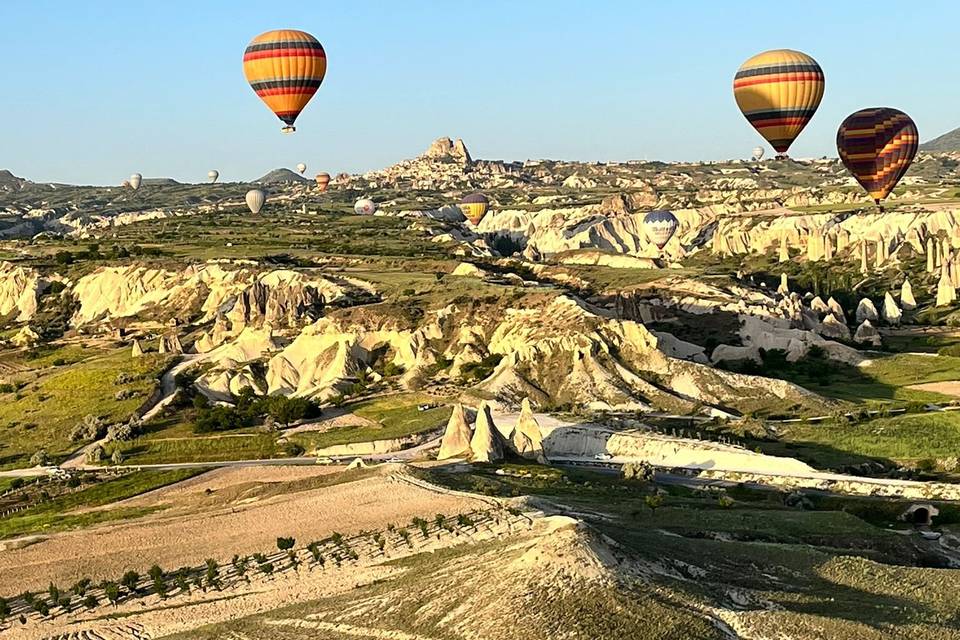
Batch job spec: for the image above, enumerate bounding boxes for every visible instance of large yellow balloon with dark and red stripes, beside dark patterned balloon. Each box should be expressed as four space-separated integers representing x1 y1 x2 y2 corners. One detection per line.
733 49 824 158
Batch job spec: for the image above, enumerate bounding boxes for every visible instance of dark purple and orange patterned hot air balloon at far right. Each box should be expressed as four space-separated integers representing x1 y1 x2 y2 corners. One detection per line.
837 107 920 211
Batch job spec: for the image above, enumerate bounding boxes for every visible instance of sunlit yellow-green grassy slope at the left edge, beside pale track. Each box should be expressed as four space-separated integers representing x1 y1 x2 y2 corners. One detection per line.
0 347 167 469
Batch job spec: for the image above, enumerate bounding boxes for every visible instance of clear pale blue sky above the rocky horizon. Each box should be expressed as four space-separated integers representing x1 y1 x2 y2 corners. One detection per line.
0 0 960 184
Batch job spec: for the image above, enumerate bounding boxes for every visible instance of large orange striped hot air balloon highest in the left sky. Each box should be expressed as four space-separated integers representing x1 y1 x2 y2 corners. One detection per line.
243 29 327 134
